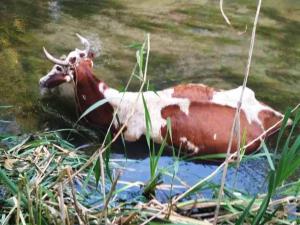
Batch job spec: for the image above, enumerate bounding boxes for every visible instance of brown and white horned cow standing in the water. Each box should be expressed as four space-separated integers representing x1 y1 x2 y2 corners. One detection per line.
40 36 282 155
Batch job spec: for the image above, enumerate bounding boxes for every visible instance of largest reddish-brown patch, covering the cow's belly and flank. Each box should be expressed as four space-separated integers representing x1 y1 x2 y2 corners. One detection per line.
161 102 263 155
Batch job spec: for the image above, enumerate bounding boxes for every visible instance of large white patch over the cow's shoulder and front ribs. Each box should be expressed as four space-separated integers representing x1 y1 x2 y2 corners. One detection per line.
99 85 190 143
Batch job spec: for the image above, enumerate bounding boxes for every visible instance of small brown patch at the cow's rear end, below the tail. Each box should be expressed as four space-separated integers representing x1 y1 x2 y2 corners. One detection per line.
258 110 282 134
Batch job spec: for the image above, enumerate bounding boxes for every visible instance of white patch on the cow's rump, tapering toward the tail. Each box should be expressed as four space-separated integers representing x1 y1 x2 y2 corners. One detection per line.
212 86 282 125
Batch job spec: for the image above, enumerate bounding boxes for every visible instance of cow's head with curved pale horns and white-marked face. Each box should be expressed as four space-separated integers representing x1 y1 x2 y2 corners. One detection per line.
40 34 94 89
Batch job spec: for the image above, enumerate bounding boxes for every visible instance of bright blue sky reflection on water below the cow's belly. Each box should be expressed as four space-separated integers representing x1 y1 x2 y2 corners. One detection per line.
78 154 268 204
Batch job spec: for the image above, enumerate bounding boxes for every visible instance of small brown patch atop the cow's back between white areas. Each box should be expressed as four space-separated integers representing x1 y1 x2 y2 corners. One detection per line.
172 84 214 102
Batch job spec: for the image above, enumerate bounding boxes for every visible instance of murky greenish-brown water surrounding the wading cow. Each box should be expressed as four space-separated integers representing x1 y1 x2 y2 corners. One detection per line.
0 0 300 197
